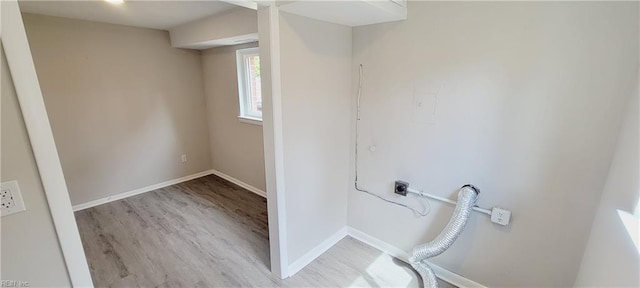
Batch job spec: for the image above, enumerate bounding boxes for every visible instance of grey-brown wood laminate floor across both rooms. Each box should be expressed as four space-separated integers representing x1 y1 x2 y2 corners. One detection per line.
76 176 452 287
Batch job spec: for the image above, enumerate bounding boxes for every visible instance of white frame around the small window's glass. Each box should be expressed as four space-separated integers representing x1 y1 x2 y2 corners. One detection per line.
236 47 262 125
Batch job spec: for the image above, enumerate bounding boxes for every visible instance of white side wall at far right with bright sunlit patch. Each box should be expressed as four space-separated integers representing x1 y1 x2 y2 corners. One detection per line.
575 80 640 287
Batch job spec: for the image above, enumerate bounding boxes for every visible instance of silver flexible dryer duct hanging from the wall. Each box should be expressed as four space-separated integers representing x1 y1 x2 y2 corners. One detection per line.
409 185 480 288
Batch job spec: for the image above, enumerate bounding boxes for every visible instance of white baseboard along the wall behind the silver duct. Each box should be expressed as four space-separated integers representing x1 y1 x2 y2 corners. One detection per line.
347 227 486 288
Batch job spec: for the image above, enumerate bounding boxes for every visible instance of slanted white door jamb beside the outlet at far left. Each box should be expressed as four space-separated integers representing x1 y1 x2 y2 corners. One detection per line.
0 0 93 287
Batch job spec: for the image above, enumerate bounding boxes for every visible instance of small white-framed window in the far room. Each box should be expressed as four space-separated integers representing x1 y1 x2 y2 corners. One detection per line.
236 48 262 124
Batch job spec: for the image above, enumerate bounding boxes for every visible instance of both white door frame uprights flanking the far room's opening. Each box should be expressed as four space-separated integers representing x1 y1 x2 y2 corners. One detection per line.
0 0 289 287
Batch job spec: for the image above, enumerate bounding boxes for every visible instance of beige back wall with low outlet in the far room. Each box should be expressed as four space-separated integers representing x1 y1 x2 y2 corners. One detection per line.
23 14 211 205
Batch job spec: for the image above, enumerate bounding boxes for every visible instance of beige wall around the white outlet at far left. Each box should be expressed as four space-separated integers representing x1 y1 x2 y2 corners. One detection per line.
0 45 71 287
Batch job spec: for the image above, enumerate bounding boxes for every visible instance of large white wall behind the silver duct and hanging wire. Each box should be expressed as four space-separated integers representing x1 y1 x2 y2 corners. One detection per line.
348 2 639 287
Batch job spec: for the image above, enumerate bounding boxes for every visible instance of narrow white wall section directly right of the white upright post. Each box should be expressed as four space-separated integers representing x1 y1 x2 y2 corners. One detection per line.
279 13 352 264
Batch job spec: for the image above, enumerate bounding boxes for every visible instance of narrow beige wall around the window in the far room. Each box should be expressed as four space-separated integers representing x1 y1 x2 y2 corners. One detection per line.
202 43 266 191
